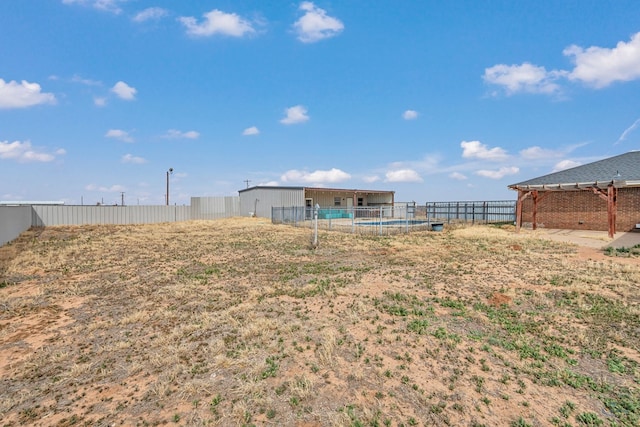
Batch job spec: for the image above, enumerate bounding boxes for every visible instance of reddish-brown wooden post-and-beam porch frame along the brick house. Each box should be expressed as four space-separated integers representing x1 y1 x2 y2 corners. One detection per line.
511 181 618 238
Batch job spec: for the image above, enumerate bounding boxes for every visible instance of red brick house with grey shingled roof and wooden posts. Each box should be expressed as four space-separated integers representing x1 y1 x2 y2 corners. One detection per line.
509 151 640 237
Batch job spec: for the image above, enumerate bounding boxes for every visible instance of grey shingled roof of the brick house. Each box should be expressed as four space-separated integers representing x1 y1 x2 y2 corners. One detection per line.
509 151 640 190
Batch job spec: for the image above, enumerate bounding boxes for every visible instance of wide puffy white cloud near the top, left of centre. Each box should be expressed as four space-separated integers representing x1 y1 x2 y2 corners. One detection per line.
178 9 255 37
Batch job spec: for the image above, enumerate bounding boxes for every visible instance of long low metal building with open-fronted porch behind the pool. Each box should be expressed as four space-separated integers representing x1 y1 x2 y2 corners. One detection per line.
238 186 395 218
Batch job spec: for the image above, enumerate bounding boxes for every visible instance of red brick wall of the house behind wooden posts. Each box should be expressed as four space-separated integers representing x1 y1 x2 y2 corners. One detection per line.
522 187 640 231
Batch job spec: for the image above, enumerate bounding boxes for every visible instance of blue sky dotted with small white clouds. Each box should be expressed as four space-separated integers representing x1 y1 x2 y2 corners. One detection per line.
0 0 640 205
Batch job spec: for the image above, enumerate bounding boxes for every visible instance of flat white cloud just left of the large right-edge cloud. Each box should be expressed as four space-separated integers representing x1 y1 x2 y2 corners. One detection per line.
483 62 567 95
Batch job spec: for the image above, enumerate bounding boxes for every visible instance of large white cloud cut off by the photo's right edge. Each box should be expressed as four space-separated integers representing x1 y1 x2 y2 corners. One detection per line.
563 33 640 88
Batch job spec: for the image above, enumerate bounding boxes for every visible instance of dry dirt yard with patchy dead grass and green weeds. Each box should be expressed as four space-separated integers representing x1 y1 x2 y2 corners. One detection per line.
0 218 640 427
